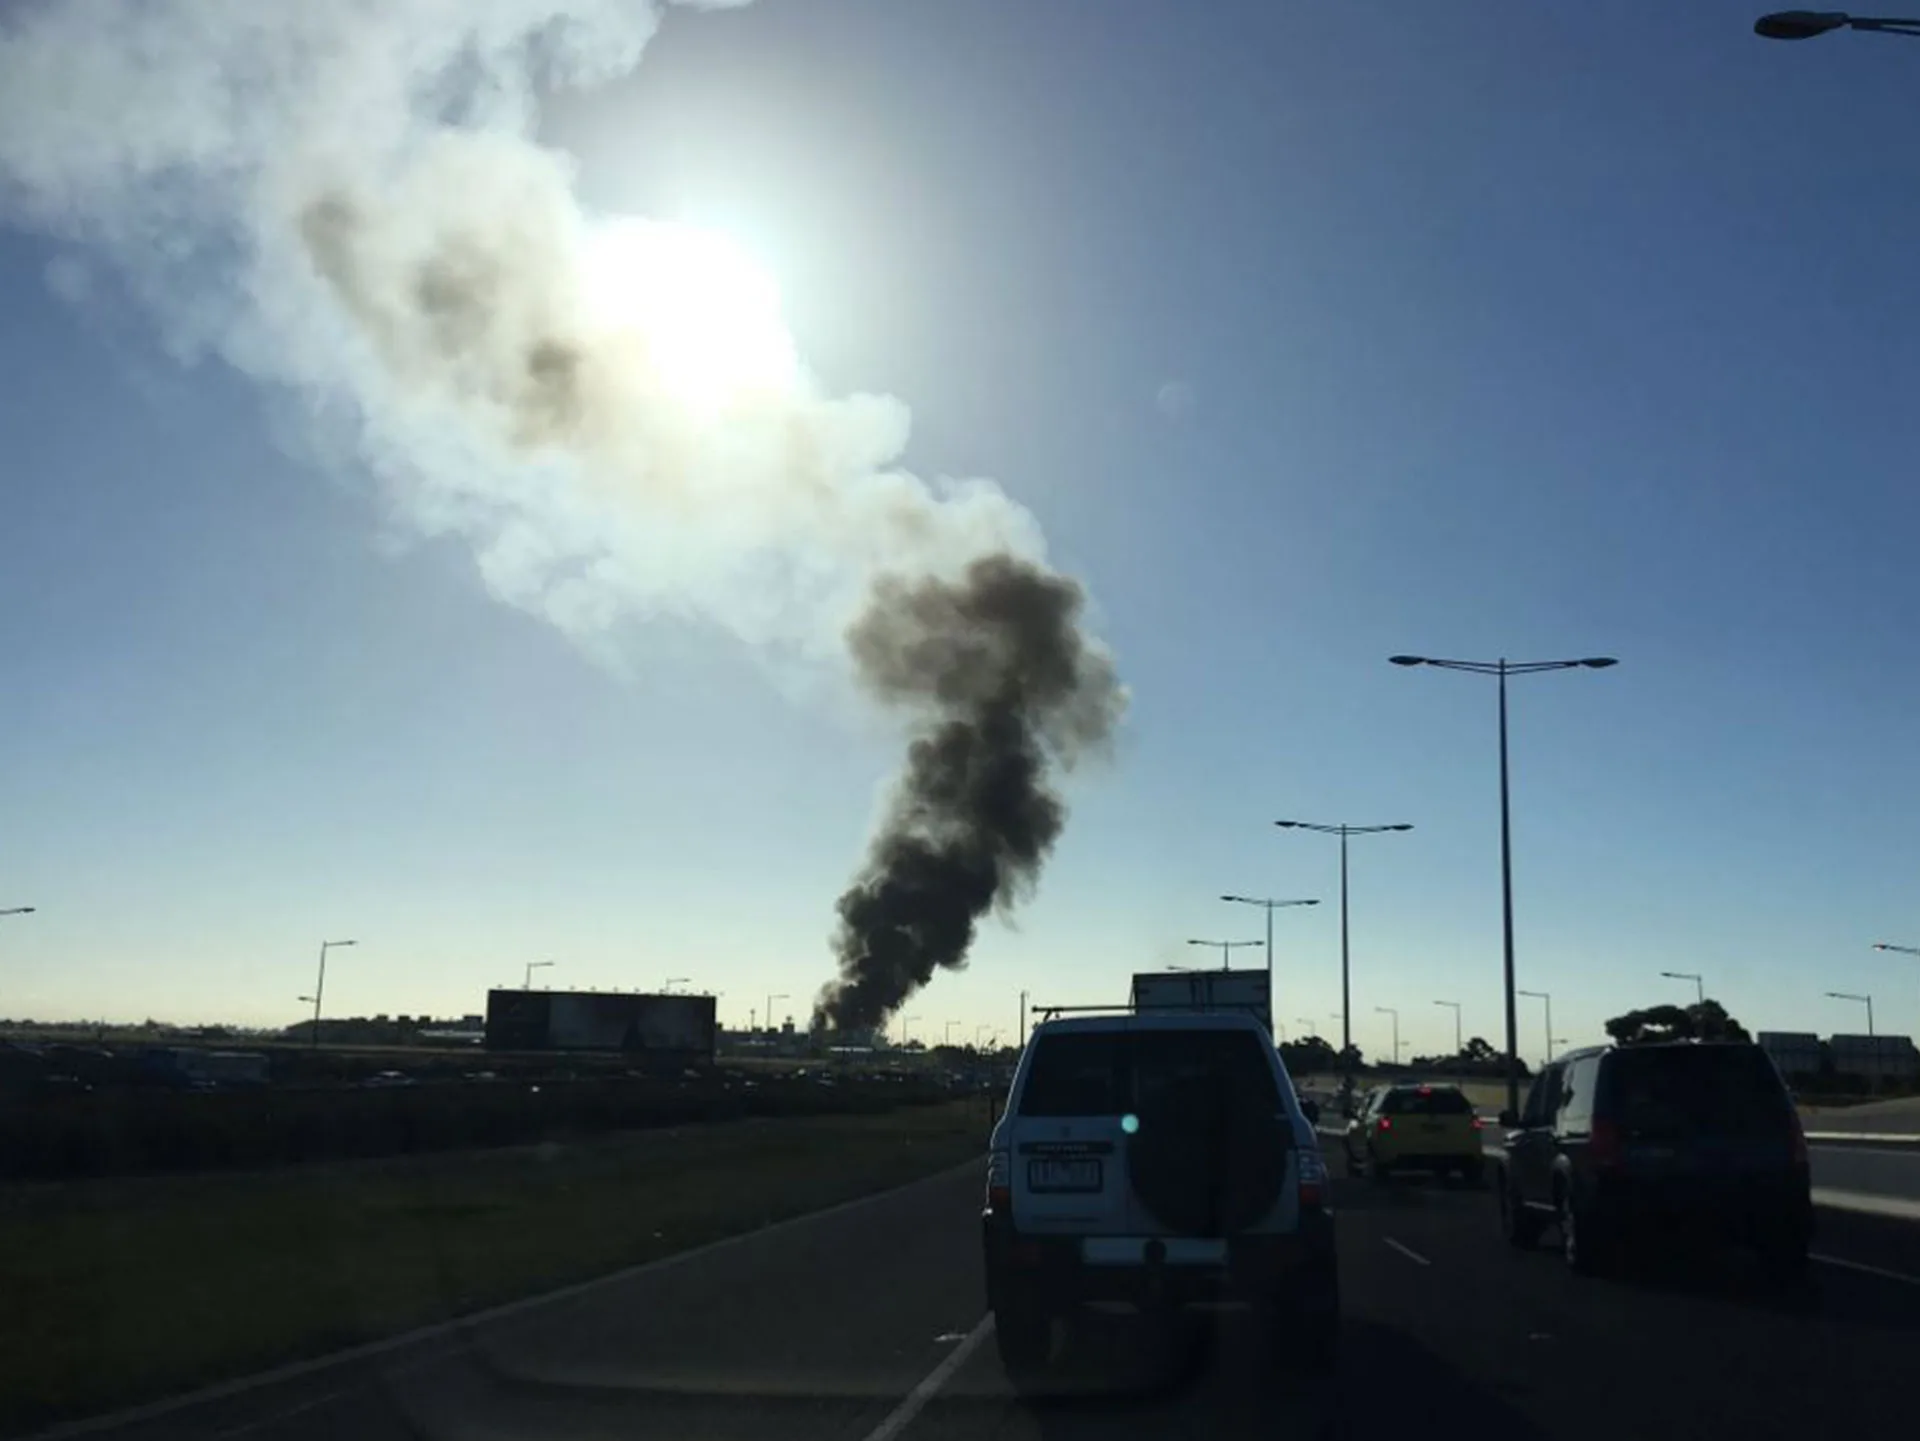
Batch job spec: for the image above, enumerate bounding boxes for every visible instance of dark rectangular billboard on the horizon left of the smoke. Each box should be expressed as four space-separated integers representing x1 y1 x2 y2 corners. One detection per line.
486 990 714 1063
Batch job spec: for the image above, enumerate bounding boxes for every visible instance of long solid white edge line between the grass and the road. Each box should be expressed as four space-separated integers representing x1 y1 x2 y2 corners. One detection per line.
25 1159 983 1441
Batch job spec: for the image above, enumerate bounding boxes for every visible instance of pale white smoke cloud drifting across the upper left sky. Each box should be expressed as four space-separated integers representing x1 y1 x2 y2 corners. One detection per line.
0 0 1043 656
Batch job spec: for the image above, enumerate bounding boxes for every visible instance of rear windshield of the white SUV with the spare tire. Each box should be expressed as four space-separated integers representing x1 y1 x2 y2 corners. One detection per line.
1020 1028 1279 1117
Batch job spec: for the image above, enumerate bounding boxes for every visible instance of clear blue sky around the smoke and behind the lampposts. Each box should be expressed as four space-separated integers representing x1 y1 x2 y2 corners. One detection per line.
0 0 1920 1055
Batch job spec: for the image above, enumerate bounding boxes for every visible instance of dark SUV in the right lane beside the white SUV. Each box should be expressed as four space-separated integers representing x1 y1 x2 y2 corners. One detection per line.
1490 1042 1812 1278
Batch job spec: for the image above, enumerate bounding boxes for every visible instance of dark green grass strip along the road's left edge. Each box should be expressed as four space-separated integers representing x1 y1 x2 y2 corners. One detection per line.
0 1101 987 1431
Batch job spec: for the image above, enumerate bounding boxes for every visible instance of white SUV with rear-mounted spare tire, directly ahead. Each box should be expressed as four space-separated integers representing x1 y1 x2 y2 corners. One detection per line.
983 1011 1340 1380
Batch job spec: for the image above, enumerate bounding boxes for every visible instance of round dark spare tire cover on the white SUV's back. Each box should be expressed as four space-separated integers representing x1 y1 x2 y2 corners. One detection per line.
1127 1076 1292 1236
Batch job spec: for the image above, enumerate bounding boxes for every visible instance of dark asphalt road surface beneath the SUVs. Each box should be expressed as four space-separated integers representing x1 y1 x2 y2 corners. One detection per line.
48 1161 1920 1441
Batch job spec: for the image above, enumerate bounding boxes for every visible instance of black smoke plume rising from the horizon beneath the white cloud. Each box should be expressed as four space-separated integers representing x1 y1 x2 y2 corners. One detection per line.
814 555 1125 1028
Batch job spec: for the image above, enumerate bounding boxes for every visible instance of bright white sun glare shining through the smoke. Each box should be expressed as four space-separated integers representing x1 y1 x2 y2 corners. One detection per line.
588 221 799 414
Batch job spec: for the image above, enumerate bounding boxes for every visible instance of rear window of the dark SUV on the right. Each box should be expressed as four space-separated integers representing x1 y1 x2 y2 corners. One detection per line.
1603 1046 1791 1136
